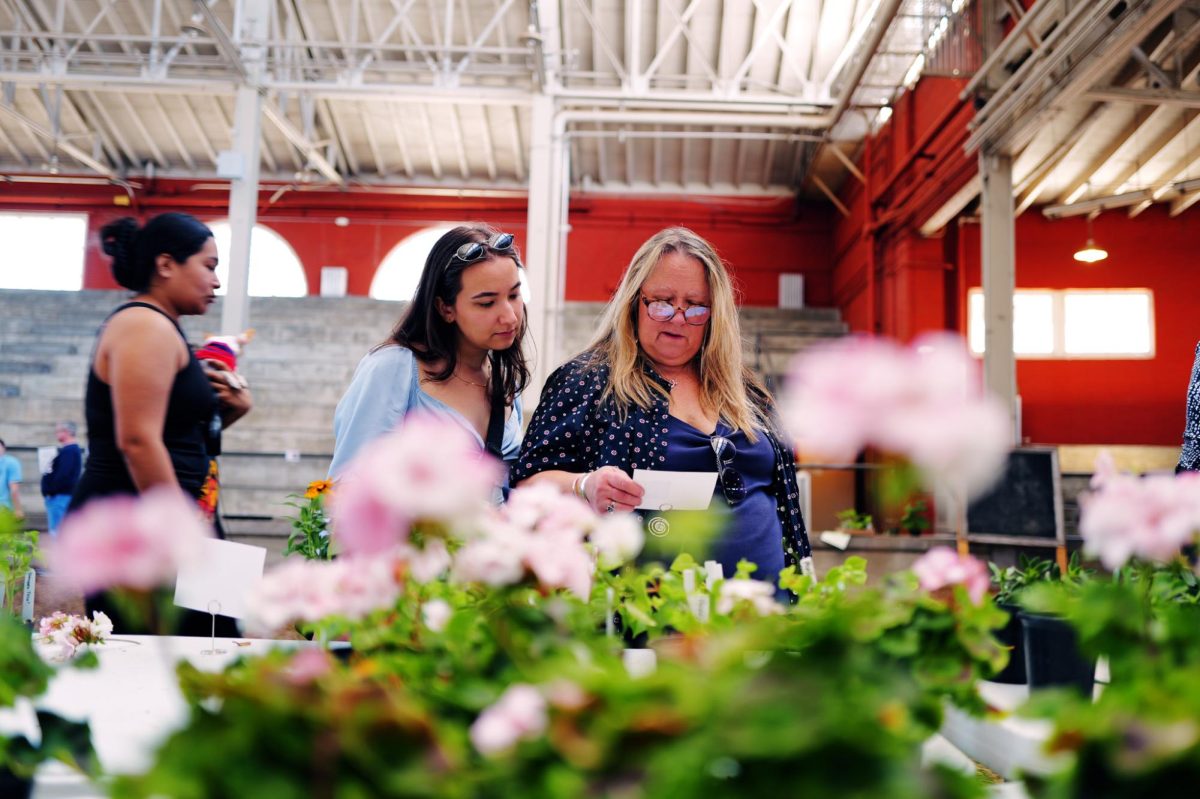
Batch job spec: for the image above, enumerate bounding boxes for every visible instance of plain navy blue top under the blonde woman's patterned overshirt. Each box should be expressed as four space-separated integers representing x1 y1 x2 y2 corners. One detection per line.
662 416 784 583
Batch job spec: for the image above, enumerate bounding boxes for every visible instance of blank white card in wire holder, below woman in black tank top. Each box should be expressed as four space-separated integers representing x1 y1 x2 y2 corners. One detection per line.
175 539 266 619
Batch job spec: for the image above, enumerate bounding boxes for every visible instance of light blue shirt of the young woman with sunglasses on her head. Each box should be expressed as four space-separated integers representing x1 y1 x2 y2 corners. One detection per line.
329 344 522 477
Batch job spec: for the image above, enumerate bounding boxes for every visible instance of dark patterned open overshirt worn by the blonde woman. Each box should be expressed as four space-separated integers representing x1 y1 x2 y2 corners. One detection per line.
512 355 812 566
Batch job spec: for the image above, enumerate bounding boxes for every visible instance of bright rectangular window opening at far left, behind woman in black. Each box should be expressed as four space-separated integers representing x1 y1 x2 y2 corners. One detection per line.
0 212 88 292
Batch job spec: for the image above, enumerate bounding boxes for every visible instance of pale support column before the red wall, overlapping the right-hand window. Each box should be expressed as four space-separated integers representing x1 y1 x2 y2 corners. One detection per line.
979 149 1021 443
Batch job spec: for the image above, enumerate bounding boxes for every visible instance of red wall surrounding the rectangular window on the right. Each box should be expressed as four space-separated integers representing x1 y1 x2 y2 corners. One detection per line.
960 205 1200 446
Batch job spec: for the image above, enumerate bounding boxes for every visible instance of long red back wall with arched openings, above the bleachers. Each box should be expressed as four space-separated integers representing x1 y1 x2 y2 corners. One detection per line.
0 181 833 306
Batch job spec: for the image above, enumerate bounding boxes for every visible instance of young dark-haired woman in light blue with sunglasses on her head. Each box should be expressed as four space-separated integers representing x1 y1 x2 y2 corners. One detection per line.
330 224 529 477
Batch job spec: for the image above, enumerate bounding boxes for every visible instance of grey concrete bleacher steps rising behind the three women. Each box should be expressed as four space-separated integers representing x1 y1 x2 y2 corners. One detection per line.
0 290 846 523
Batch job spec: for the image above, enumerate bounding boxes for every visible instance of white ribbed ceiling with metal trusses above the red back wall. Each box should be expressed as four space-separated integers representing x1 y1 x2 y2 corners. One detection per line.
0 0 965 193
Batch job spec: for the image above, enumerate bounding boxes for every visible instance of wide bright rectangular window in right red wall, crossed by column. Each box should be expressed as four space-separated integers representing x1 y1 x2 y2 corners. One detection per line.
967 289 1154 359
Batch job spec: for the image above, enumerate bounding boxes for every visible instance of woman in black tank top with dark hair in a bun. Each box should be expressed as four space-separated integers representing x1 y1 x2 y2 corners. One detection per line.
71 214 251 636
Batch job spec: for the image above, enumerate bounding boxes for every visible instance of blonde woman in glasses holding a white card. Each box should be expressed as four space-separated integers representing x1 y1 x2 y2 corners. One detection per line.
512 228 811 582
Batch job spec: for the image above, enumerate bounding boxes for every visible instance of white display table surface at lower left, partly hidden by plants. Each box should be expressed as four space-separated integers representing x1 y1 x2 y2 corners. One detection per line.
0 636 316 799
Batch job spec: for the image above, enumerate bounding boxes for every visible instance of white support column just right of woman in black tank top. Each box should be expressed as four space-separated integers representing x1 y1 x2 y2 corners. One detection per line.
220 0 271 335
